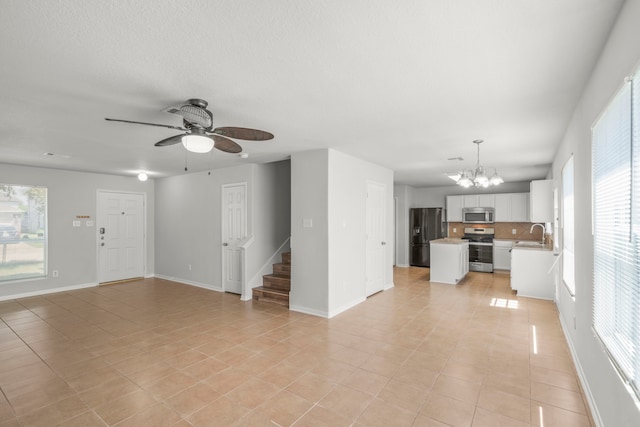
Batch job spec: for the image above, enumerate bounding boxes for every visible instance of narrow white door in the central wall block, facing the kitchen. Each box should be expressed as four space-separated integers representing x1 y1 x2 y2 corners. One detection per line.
366 182 387 296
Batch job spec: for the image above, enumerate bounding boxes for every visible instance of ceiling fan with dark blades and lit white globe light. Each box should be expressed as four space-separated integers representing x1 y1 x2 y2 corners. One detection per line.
105 98 273 153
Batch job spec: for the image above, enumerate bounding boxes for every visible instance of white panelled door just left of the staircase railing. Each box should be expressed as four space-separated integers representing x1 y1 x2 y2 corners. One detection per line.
222 183 247 294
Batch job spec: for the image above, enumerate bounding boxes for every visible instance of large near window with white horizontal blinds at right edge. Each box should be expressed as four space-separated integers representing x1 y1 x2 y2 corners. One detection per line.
592 69 640 398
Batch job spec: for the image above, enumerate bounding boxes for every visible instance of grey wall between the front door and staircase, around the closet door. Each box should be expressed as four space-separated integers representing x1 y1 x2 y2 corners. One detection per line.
155 161 291 290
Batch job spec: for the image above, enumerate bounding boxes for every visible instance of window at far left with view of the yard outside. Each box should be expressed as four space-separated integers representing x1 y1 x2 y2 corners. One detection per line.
0 183 47 282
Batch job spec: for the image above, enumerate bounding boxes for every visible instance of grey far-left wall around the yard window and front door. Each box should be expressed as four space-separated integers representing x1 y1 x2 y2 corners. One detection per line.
0 164 155 299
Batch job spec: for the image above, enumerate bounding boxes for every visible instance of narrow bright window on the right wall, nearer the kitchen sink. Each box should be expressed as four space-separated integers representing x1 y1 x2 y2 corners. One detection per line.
562 156 576 296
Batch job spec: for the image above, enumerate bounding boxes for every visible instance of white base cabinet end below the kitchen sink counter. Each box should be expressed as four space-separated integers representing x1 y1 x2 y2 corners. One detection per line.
511 245 555 300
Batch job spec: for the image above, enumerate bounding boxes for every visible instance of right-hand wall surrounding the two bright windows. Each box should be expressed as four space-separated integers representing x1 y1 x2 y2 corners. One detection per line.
553 0 640 426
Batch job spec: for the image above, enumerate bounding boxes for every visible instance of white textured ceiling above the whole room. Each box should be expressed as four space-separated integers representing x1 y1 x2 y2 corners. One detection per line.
0 0 623 186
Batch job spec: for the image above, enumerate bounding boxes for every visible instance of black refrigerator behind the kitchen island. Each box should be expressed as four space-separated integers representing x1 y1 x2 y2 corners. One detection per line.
409 208 444 267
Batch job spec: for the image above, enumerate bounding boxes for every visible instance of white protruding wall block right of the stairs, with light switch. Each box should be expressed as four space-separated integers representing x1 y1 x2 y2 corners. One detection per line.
290 150 394 317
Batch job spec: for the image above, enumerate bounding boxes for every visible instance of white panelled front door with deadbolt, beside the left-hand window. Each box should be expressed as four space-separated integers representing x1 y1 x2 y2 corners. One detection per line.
97 191 145 283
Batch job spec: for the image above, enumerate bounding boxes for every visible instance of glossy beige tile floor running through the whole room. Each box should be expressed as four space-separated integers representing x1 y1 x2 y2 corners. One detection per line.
0 268 593 427
